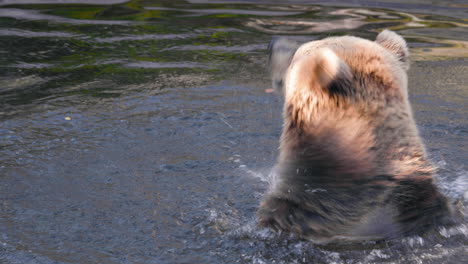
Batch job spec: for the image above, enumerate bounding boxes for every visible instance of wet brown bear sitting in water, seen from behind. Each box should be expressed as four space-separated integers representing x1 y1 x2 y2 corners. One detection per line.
257 30 450 243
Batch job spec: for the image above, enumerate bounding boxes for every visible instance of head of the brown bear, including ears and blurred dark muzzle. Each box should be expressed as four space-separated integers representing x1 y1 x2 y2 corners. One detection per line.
270 30 409 102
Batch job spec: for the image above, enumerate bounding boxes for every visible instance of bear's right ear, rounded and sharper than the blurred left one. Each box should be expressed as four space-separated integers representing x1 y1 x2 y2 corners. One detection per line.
375 29 409 70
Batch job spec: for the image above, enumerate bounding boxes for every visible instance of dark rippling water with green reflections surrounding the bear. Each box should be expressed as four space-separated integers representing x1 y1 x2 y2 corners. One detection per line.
0 0 468 264
